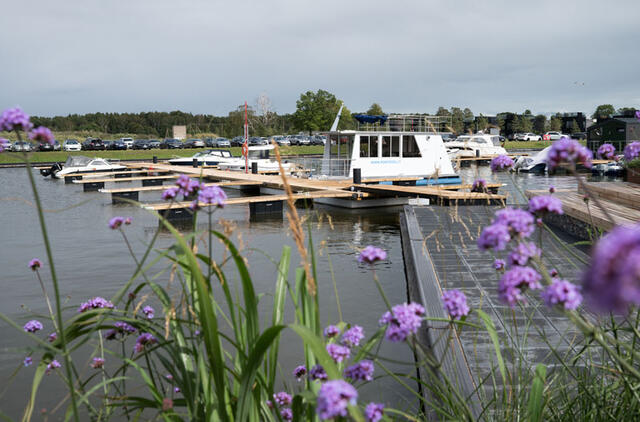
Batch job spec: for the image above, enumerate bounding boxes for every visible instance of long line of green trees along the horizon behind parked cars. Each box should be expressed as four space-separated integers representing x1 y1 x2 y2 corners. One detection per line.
32 90 634 138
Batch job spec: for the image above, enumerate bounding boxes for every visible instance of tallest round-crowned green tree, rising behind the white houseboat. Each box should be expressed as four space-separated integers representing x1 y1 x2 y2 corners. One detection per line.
294 89 344 132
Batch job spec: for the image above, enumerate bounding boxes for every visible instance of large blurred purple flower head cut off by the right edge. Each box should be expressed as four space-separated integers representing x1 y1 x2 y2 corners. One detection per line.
582 224 640 313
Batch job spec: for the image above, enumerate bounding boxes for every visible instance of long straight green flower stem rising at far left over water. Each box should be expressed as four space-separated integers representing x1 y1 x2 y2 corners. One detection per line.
21 138 80 422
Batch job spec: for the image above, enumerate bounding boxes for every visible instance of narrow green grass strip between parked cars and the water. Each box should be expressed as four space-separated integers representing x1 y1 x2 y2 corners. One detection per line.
0 146 323 164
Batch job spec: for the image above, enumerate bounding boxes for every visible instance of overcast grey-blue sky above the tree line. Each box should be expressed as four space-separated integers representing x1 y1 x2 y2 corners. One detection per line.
0 0 640 115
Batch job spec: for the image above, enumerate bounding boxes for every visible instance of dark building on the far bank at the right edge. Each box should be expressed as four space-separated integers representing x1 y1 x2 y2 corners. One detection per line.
587 116 640 153
